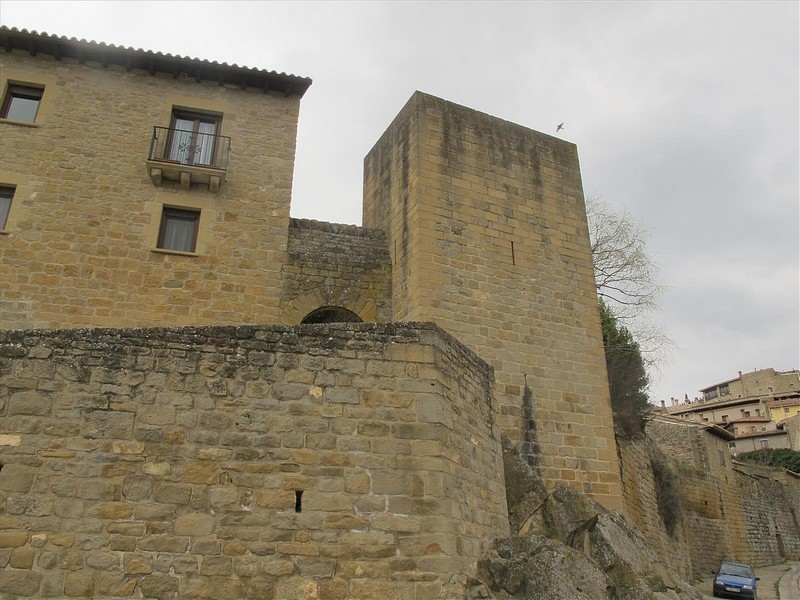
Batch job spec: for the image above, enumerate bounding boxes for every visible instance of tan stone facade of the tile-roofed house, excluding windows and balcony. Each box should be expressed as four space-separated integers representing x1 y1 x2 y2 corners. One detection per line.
0 50 300 329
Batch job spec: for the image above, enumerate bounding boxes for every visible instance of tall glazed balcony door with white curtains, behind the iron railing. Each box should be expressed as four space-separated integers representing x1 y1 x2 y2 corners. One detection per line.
166 111 221 165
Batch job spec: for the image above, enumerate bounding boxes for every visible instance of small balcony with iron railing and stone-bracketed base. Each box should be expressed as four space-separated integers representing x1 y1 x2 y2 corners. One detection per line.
147 127 231 192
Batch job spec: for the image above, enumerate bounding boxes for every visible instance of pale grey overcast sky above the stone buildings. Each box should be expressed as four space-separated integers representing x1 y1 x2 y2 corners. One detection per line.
0 0 800 400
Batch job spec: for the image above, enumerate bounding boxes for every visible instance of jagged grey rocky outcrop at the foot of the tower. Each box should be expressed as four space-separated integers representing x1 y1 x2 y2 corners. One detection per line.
470 439 703 600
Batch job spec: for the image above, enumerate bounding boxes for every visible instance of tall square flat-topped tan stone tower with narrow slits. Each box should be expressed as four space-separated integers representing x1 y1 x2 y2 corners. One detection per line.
363 92 622 508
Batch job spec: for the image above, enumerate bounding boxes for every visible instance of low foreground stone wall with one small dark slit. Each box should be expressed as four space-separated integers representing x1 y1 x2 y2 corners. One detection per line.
0 323 508 600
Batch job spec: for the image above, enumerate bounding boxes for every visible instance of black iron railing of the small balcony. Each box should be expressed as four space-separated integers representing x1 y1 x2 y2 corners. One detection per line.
149 127 231 171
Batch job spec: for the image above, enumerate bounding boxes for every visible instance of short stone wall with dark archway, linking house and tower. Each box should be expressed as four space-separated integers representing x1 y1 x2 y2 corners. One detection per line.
281 219 392 324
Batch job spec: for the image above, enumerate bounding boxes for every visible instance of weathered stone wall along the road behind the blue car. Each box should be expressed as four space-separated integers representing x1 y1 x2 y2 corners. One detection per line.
618 420 800 579
